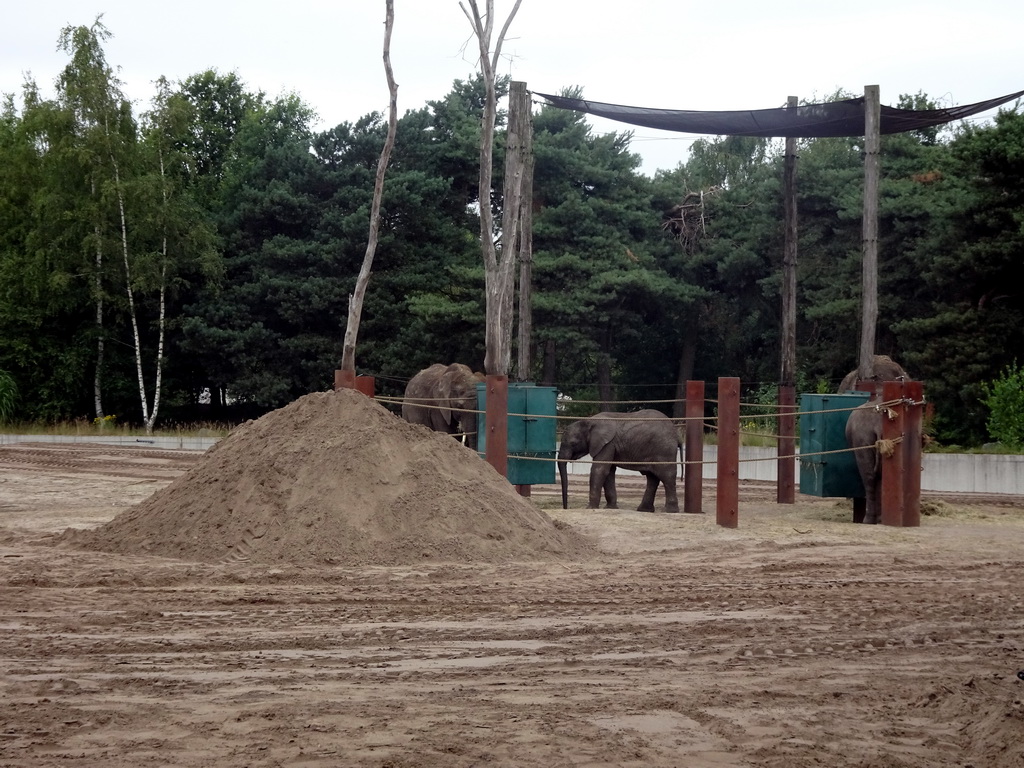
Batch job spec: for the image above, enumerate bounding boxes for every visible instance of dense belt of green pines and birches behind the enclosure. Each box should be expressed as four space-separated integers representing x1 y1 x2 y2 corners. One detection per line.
0 20 1024 443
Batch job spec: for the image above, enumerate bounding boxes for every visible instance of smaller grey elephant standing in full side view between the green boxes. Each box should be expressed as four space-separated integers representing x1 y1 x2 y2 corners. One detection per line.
558 411 680 512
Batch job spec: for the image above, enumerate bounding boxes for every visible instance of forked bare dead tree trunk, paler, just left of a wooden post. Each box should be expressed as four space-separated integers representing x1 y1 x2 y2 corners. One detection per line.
459 0 522 376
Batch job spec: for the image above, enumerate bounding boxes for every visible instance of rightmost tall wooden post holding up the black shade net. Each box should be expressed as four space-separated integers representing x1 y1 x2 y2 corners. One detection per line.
857 85 882 379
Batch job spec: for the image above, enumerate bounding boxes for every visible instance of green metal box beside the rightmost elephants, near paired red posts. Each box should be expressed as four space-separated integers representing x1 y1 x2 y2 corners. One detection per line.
800 392 869 499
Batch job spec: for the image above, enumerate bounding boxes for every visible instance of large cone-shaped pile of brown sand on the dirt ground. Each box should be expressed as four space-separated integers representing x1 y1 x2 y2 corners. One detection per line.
61 390 593 565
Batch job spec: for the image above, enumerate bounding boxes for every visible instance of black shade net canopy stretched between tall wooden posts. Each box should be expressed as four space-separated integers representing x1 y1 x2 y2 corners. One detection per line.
534 90 1024 138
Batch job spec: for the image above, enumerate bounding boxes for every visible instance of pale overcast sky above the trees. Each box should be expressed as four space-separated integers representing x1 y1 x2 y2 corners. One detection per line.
0 0 1024 174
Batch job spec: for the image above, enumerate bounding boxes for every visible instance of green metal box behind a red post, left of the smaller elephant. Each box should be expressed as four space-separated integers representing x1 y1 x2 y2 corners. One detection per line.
476 382 557 485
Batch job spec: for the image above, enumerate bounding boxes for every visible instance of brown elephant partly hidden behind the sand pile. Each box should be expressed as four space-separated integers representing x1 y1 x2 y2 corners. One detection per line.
401 362 486 451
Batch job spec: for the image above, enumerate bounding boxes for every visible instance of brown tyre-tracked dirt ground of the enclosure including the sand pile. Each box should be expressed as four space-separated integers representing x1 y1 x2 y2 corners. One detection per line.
0 395 1024 768
